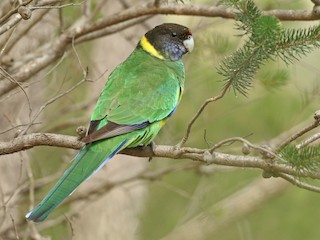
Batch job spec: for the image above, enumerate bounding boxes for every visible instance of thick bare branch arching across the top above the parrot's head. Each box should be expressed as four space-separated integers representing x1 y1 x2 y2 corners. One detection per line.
0 1 320 97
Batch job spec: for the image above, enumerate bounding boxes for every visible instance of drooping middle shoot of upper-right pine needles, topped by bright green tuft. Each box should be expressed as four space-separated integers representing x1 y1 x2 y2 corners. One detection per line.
218 16 281 95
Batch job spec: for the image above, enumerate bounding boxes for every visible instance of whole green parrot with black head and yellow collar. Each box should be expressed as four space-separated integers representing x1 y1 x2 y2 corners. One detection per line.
26 23 194 222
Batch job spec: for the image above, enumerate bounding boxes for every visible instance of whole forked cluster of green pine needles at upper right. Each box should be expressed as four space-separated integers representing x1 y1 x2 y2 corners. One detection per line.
217 0 320 95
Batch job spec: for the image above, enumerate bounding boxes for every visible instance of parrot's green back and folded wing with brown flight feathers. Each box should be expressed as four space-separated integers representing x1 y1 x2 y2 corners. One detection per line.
84 48 184 143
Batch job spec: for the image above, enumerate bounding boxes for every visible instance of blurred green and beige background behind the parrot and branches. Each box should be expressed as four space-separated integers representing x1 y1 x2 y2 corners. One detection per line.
0 0 320 240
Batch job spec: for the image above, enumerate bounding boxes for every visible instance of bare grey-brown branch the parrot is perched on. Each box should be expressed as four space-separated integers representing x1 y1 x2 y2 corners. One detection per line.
0 133 320 179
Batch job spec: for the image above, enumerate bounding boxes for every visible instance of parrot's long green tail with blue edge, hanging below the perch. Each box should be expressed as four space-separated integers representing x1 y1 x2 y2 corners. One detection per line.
26 140 127 222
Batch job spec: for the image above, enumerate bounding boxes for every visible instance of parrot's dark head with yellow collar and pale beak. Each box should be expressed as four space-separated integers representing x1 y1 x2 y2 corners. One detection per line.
140 23 194 61
